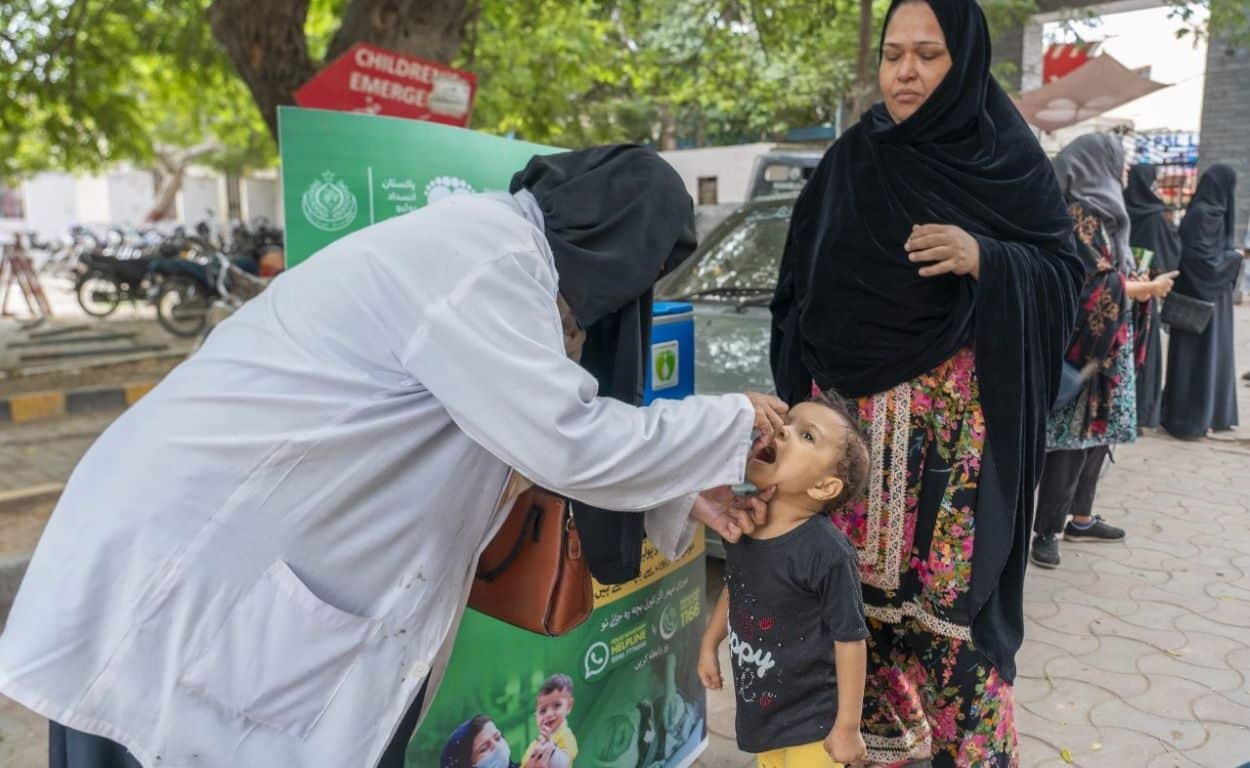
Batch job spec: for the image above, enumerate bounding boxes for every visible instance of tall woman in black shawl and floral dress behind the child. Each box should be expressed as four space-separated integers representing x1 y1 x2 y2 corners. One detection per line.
771 0 1084 767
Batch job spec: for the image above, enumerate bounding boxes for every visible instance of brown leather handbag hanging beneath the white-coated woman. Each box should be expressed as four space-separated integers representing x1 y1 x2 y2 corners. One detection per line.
469 488 595 637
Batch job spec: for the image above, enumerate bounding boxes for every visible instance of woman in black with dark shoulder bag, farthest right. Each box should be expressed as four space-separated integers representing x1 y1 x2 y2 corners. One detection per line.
1163 165 1241 440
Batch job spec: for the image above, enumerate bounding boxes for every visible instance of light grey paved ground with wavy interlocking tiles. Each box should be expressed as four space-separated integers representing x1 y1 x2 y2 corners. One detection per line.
0 310 1250 768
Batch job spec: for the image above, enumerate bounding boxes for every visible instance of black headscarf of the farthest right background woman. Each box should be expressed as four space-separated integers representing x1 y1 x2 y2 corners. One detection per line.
1176 165 1240 301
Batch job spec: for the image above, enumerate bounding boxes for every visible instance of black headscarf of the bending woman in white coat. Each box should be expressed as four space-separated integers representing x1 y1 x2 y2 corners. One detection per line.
511 145 695 584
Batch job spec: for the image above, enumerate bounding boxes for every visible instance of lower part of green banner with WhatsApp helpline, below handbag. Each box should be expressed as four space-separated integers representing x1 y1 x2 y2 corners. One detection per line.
406 542 708 768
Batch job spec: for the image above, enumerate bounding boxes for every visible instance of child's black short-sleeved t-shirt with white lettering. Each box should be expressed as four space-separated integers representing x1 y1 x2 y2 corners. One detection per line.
725 515 868 753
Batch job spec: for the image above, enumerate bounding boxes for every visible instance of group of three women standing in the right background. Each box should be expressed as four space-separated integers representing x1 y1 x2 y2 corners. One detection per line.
1030 134 1243 568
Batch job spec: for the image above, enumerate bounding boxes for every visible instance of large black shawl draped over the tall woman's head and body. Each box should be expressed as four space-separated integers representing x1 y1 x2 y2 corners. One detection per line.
771 0 1084 679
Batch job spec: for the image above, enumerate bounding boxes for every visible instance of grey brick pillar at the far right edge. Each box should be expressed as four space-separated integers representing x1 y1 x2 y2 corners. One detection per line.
1198 40 1250 243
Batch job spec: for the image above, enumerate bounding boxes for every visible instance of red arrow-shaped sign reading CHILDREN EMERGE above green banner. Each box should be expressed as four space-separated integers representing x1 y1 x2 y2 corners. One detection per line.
295 43 478 128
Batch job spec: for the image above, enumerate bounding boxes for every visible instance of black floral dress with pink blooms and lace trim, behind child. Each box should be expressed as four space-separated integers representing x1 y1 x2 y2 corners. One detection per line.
834 349 1019 768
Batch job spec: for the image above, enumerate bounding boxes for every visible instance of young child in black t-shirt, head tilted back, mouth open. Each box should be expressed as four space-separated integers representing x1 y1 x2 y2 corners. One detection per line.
699 397 869 768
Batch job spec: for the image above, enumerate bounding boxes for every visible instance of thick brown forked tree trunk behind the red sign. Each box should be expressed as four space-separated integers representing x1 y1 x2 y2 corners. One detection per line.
209 0 474 141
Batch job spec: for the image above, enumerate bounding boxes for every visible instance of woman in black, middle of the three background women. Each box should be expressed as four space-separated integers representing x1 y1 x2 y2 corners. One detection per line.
1124 165 1180 428
